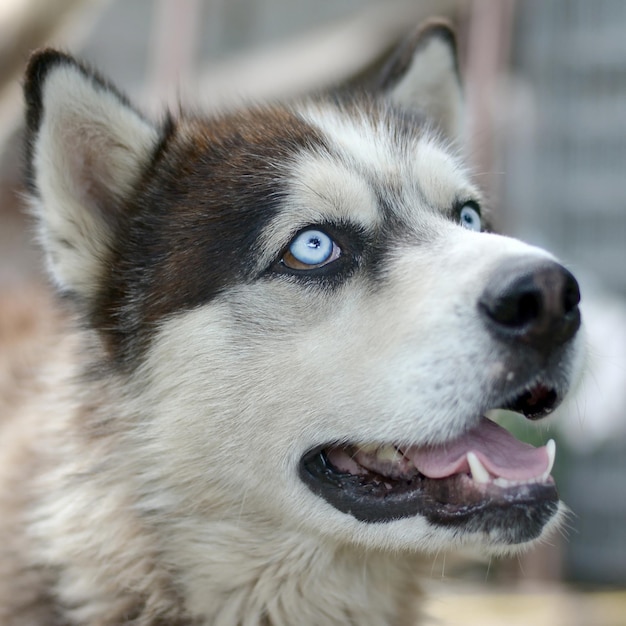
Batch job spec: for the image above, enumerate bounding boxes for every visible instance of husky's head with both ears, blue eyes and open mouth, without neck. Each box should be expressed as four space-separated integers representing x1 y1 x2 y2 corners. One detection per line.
25 23 580 551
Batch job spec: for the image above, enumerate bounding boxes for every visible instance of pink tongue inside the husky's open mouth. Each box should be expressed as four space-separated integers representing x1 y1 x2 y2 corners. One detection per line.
403 417 549 481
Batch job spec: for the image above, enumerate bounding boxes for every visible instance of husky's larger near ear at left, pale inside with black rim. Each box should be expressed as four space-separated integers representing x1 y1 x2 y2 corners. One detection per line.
24 50 160 300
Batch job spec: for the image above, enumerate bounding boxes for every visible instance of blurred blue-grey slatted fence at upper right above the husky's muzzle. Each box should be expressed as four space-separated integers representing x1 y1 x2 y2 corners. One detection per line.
505 0 626 298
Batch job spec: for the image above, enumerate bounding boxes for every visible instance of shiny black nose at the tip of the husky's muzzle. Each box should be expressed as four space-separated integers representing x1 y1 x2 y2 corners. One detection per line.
478 261 580 354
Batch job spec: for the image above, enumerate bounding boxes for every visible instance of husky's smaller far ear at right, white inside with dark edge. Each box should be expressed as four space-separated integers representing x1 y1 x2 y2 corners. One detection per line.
374 21 464 140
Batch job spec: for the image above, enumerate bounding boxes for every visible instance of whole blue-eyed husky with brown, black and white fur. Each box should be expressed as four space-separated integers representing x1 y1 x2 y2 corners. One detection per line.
0 22 581 626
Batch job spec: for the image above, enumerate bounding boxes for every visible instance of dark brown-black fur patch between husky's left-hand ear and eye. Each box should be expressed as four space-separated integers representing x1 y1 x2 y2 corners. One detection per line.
92 109 324 365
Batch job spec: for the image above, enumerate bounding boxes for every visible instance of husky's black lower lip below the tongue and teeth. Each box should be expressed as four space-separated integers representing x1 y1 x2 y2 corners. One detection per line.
299 444 559 544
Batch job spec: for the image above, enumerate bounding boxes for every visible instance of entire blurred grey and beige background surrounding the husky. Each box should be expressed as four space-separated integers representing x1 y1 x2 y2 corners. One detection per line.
0 0 626 626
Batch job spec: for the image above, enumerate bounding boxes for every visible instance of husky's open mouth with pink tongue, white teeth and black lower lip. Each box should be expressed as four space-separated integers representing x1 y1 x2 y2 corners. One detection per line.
300 386 559 543
